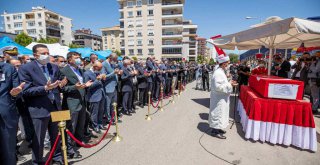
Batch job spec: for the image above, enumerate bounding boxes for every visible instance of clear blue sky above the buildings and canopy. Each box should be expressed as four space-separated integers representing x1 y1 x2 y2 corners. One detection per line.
0 0 320 38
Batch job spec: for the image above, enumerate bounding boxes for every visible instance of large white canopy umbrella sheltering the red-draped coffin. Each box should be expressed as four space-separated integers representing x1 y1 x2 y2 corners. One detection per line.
207 18 320 75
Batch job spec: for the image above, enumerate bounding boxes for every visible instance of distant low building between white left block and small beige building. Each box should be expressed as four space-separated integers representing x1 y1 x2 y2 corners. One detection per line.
72 28 102 51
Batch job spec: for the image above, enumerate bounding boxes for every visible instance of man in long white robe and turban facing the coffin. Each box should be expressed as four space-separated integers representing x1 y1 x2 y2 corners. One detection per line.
209 55 236 139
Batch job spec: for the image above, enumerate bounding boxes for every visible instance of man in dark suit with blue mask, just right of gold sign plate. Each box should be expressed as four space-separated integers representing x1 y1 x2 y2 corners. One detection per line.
60 52 92 158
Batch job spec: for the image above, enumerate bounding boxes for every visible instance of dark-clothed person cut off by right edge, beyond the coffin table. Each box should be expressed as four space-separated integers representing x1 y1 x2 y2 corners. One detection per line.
308 52 320 114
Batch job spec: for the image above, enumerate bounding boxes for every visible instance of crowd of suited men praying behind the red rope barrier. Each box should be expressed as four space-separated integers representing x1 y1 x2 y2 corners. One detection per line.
0 44 200 165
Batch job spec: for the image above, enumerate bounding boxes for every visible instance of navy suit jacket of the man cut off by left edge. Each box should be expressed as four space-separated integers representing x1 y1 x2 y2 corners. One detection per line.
0 62 19 128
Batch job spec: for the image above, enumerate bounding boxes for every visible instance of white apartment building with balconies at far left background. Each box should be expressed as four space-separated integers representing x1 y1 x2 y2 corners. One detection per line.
1 7 73 45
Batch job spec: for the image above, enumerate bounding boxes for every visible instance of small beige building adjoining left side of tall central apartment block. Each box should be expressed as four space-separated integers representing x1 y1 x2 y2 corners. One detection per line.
100 26 122 51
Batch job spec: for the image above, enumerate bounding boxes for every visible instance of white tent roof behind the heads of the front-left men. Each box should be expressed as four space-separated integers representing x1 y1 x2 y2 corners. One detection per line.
26 42 69 58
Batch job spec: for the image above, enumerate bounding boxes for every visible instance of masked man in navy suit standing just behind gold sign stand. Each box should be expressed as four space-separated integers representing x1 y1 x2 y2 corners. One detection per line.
19 44 67 164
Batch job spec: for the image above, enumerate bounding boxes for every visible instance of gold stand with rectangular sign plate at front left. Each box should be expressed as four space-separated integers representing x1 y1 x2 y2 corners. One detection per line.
50 110 71 165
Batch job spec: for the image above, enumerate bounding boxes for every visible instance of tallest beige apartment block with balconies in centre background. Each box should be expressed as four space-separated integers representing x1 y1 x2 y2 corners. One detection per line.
118 0 194 60
